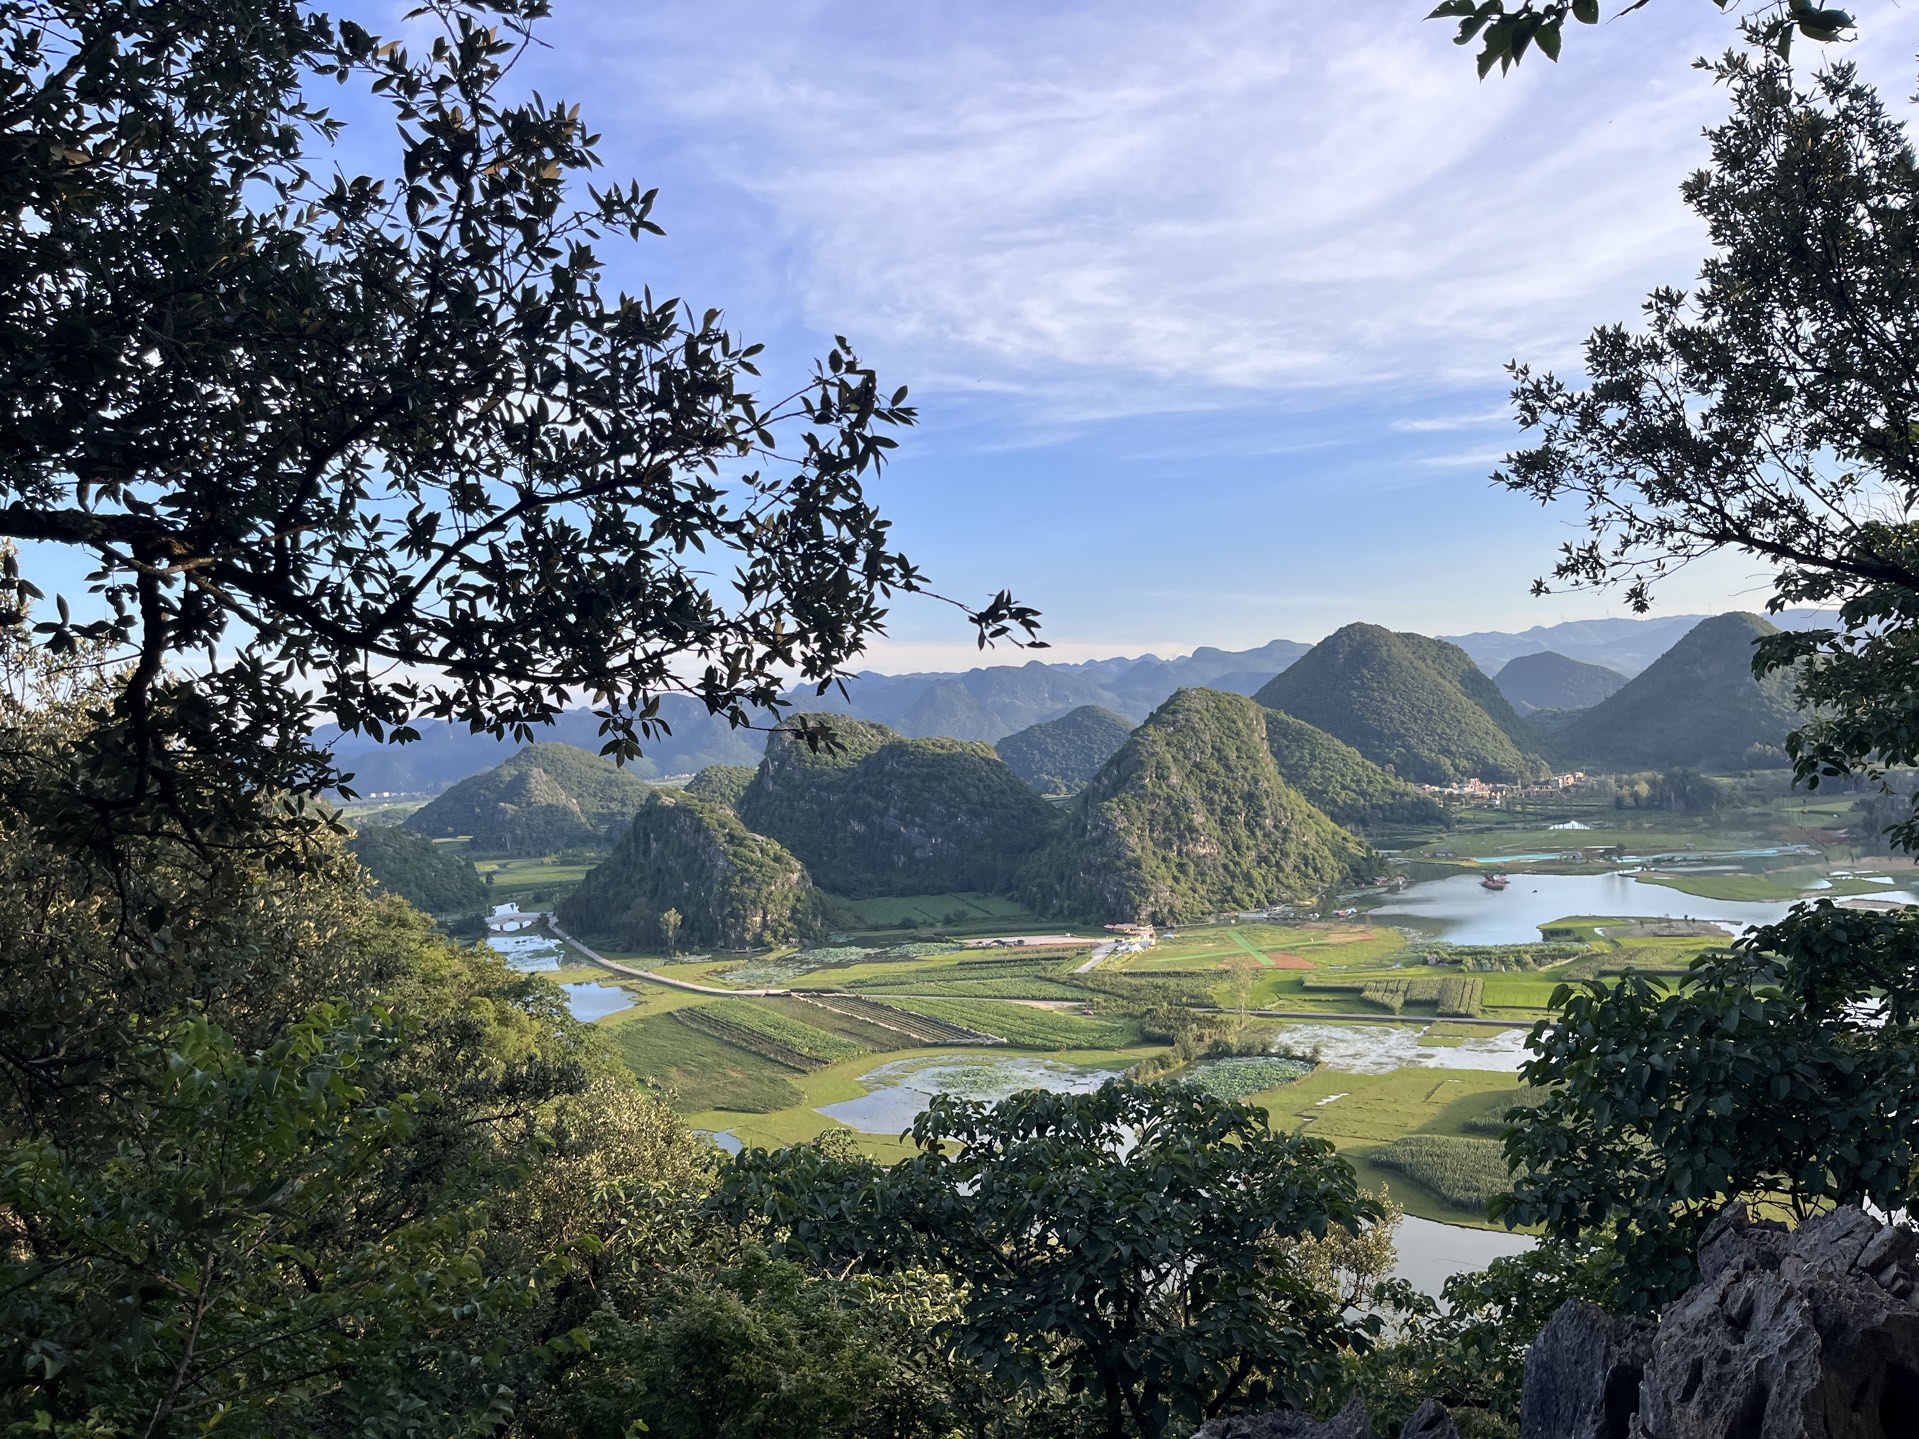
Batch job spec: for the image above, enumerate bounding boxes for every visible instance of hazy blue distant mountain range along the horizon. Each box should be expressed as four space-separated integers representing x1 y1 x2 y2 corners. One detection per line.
317 610 1829 796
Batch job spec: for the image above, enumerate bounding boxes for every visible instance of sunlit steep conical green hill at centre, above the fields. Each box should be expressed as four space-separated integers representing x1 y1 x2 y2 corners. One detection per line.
1027 689 1372 923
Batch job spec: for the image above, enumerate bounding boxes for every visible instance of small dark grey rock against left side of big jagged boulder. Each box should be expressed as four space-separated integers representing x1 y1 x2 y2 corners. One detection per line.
1520 1299 1652 1439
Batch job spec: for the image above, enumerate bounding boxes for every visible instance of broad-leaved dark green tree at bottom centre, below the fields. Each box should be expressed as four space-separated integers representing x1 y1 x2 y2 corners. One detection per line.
722 1080 1382 1439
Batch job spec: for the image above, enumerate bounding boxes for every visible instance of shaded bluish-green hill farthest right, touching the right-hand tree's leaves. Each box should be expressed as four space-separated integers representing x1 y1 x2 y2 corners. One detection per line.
1539 612 1800 771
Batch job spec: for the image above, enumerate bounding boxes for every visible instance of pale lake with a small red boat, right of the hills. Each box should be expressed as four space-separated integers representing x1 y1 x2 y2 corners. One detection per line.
1368 873 1909 944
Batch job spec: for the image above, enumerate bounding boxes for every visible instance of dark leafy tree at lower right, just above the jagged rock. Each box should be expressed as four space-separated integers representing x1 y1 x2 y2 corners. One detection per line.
1504 900 1919 1309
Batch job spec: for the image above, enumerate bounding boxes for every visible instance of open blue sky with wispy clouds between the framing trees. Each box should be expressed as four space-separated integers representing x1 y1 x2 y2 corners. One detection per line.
194 0 1919 670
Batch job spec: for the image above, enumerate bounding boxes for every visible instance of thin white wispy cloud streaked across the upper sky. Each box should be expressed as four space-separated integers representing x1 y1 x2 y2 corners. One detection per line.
537 0 1919 430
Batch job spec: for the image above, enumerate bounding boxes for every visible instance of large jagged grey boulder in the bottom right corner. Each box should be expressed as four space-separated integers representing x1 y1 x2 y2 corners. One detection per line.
1627 1209 1919 1439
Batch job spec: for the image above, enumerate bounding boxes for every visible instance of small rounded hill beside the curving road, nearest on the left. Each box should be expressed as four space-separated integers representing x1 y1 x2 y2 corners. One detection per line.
558 790 819 950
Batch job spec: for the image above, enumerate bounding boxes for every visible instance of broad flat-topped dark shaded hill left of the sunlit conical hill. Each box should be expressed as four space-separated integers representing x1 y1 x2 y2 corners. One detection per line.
739 716 1055 898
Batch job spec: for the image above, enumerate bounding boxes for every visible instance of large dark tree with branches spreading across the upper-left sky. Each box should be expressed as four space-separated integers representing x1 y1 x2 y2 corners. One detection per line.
0 0 1034 855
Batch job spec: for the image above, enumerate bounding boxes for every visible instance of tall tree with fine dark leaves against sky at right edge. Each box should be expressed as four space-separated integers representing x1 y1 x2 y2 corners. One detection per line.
1499 56 1919 838
